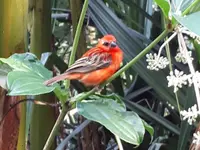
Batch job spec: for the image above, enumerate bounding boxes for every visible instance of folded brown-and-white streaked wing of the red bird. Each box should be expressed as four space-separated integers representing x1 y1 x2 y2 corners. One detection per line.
66 52 112 73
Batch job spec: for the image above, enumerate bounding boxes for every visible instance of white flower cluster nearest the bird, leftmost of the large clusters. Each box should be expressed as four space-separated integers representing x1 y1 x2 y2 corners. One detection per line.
146 53 169 71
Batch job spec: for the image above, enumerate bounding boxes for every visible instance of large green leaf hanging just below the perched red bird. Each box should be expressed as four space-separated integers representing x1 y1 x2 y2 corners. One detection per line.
77 99 145 145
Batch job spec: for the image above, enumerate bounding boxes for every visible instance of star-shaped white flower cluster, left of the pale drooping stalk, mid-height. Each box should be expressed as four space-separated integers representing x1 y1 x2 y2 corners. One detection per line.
167 69 190 93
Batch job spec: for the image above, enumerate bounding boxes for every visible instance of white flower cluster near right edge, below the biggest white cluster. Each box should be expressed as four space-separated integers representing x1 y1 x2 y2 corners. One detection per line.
180 104 200 125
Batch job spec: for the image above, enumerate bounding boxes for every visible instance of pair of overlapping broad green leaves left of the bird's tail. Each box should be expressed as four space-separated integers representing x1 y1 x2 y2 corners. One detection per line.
0 53 56 96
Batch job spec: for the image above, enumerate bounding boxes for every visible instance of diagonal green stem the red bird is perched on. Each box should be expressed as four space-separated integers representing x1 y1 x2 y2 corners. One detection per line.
43 29 169 150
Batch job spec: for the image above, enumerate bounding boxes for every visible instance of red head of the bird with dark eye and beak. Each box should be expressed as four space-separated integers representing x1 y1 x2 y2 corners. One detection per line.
97 34 118 51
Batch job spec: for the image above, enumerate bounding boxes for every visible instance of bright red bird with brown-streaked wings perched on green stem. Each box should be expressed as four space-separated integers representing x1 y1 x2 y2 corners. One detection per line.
44 35 123 86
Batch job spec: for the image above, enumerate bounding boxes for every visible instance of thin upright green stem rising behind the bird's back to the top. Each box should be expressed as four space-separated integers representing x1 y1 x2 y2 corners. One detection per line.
65 0 89 88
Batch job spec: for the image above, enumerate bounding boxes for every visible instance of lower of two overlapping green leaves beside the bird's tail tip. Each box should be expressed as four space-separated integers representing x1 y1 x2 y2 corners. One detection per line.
7 71 55 95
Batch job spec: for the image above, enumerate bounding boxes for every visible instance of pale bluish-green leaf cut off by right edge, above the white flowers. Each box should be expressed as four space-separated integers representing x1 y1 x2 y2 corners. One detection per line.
173 11 200 36
